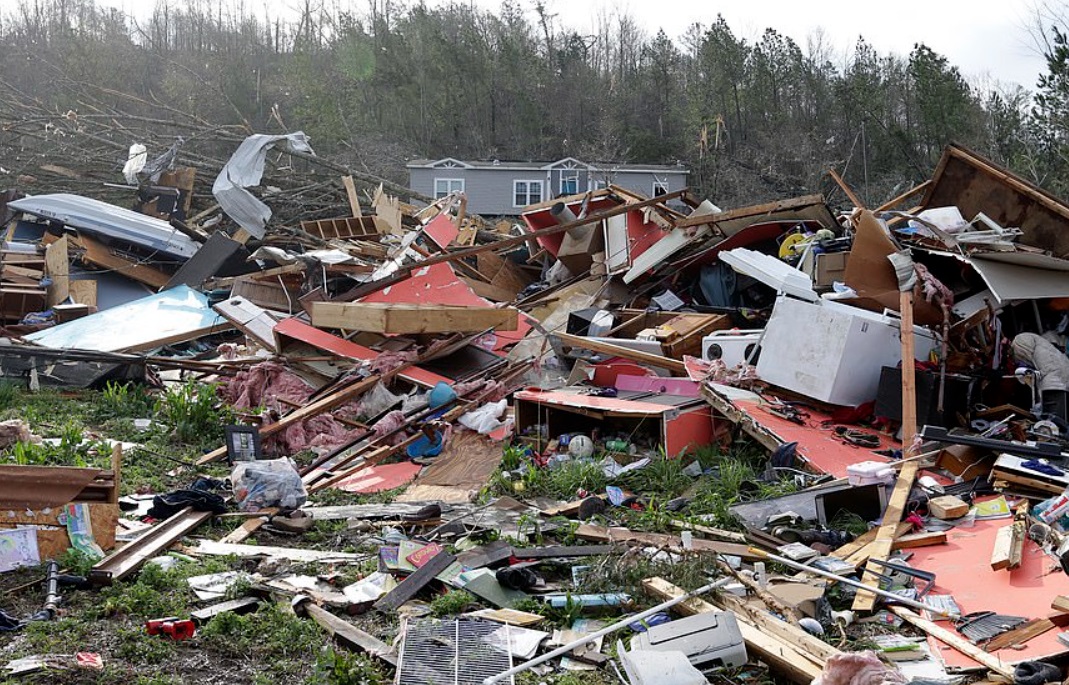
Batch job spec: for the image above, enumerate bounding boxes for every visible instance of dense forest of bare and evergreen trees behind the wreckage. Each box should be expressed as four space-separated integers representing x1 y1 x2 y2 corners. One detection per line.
0 0 1069 206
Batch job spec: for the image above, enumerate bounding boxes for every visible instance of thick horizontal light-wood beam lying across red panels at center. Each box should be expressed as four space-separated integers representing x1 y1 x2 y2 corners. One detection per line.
312 302 520 334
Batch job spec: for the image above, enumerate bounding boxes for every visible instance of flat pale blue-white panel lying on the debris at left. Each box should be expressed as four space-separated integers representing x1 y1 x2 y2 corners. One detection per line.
26 285 231 352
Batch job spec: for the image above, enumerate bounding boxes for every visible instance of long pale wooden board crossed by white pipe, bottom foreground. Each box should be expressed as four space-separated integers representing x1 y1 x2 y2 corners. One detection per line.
642 578 825 684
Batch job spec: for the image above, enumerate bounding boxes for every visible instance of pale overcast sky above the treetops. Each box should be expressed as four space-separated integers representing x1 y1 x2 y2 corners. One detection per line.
94 0 1051 90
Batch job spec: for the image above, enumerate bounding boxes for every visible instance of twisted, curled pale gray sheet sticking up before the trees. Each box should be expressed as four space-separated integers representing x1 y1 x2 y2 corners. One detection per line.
212 130 315 238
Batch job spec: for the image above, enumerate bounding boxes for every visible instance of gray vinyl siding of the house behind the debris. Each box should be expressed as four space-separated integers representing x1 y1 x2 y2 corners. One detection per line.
408 167 686 216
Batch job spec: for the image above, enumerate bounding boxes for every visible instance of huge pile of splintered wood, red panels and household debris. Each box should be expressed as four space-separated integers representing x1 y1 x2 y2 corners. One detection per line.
0 134 1069 685
